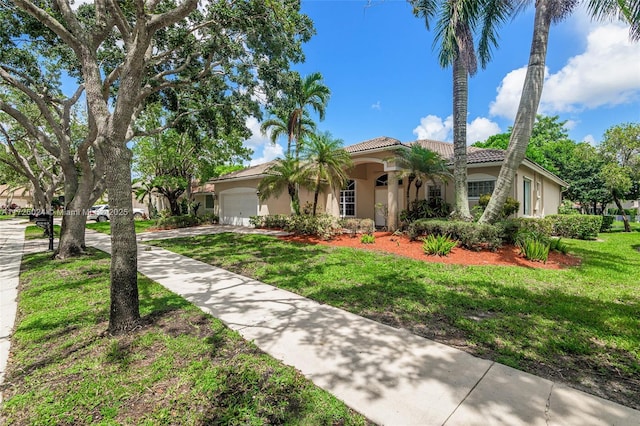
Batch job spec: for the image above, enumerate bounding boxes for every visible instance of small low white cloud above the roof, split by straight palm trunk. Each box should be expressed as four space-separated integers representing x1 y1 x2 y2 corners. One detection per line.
413 115 501 144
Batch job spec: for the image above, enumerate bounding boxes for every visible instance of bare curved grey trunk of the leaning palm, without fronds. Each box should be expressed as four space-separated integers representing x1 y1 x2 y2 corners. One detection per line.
479 0 551 223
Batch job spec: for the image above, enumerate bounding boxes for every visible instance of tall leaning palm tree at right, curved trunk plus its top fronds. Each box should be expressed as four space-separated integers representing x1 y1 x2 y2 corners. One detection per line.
480 0 640 223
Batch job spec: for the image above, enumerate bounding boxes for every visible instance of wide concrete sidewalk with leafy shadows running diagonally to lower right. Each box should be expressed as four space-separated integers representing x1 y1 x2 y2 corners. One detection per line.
87 232 640 426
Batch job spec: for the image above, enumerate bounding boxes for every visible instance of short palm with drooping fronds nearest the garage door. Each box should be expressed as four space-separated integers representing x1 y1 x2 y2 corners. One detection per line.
258 155 303 215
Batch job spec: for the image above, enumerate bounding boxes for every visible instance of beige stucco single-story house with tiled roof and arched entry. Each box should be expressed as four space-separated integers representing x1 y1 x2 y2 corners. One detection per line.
211 137 568 227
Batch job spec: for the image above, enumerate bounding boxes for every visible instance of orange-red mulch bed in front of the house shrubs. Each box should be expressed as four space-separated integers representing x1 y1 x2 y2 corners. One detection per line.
280 232 580 269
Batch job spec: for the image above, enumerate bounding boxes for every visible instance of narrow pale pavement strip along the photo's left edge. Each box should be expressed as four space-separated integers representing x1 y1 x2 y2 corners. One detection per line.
0 220 26 403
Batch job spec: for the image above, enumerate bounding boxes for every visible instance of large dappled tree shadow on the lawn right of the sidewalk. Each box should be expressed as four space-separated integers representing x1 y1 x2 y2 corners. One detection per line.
255 264 640 408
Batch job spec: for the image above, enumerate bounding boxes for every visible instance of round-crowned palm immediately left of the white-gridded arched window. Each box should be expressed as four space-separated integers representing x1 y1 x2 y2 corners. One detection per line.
303 132 353 216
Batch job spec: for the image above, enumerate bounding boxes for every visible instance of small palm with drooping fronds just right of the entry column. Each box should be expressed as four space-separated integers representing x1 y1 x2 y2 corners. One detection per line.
397 143 451 210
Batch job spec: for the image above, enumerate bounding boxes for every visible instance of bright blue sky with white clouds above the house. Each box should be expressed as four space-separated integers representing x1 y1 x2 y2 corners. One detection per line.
247 0 640 164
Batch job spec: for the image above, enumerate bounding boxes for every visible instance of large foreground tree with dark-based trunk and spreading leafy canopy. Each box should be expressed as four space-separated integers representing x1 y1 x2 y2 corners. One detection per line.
7 0 312 333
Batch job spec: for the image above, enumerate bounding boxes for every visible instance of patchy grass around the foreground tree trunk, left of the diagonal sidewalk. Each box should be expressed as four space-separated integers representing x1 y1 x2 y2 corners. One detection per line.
0 249 366 425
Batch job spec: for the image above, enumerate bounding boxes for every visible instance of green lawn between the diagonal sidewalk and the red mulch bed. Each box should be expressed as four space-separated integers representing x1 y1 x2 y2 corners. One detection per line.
152 233 640 408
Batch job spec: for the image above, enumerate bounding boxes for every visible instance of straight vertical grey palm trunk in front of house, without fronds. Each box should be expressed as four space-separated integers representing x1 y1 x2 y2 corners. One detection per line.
453 55 471 220
